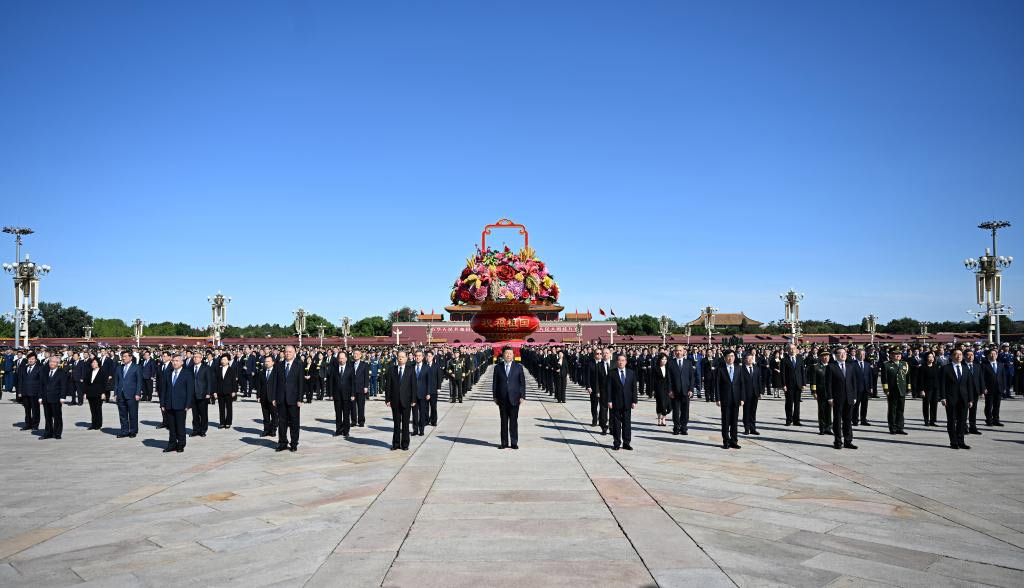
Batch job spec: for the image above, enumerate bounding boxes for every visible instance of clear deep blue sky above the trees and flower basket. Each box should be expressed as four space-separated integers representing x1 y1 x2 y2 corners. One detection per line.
0 0 1024 325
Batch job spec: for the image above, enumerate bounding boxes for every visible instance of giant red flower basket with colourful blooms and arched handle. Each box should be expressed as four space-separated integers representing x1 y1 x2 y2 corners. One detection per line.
452 219 558 356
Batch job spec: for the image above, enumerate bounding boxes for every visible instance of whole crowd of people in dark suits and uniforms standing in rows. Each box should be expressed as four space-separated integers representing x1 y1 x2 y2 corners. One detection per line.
0 343 1024 453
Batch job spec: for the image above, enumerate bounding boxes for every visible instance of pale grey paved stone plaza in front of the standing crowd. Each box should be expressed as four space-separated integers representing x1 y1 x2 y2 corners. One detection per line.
0 375 1024 588
